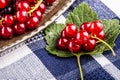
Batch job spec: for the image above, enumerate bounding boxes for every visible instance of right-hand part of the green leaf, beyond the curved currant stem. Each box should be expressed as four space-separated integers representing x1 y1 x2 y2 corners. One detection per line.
82 19 120 55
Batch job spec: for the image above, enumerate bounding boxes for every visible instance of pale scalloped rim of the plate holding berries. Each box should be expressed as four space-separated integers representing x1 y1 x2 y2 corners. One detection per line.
0 0 75 52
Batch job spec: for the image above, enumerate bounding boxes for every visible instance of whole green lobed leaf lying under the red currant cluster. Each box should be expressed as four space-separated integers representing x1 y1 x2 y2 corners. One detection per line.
45 3 120 57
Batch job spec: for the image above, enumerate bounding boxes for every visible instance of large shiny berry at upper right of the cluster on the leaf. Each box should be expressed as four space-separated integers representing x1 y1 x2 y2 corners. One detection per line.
89 21 103 34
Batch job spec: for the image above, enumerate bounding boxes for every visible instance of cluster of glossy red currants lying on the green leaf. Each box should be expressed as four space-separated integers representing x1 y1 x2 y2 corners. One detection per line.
58 21 105 52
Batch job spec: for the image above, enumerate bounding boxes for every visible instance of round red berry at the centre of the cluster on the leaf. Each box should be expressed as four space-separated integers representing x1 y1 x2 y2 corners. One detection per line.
75 30 90 45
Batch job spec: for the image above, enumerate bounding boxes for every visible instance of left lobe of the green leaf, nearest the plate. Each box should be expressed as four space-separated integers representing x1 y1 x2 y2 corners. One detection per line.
45 23 73 57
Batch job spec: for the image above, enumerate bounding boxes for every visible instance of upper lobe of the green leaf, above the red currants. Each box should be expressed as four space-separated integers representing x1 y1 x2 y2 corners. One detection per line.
66 3 98 26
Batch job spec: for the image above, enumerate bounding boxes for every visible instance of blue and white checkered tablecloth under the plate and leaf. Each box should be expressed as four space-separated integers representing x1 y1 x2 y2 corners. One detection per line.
0 0 120 80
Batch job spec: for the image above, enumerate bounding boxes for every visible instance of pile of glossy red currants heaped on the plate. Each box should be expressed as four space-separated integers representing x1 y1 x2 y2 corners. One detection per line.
0 0 55 39
